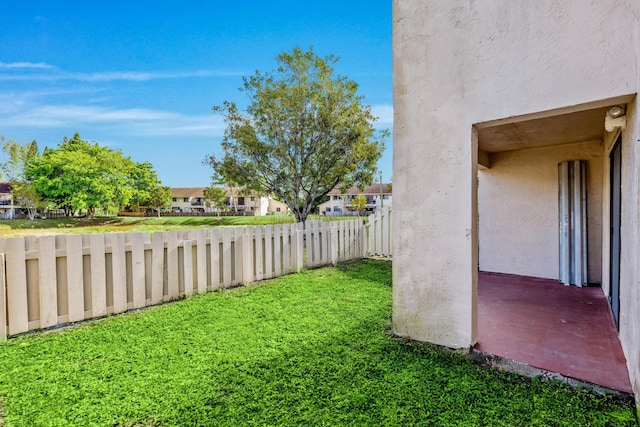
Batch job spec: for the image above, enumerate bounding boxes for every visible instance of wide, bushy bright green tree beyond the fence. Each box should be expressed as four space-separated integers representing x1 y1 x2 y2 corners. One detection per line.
27 133 157 217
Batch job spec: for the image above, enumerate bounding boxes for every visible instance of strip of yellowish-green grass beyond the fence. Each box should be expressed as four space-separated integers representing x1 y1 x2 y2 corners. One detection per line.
0 215 364 237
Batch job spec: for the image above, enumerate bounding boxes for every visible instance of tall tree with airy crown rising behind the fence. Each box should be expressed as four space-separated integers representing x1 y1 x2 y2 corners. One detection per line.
205 48 388 222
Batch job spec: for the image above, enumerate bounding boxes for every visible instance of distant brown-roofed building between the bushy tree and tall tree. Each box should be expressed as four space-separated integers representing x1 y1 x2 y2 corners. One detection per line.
171 187 289 216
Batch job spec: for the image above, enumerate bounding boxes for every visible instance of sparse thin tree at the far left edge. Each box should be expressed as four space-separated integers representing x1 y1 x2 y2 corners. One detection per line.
0 137 43 221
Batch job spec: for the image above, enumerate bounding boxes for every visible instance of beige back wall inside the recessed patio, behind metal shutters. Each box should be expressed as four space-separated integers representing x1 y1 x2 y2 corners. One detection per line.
478 142 603 283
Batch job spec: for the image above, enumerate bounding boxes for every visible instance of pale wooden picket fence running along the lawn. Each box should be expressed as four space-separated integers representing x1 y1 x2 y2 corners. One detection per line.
0 211 390 340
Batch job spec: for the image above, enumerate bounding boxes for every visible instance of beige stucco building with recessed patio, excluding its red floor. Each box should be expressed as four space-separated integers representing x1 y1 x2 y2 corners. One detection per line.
393 0 640 406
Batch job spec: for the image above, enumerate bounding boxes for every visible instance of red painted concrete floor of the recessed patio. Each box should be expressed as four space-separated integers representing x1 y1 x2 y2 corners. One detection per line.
475 272 632 393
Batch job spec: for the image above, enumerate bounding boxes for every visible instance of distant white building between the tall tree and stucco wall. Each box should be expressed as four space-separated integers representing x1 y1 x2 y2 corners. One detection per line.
319 184 392 216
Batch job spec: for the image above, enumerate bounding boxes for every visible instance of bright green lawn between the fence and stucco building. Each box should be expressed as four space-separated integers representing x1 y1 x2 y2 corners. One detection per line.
0 260 635 426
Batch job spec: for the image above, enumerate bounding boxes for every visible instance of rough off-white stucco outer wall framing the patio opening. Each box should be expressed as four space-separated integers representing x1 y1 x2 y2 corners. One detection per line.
393 0 640 402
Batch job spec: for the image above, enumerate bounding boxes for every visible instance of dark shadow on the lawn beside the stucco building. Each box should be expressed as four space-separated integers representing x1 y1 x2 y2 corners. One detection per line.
155 260 633 426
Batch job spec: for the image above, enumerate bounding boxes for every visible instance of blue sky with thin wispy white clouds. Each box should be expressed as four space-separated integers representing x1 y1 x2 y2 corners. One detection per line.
0 0 393 187
